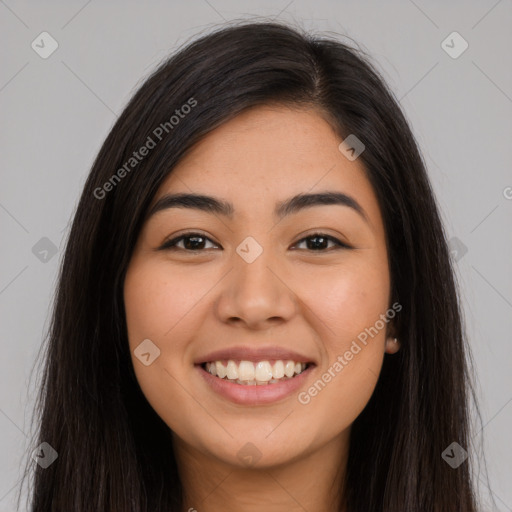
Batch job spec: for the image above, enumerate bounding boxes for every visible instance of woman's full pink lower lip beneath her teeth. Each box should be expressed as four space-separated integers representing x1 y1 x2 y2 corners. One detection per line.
196 365 314 405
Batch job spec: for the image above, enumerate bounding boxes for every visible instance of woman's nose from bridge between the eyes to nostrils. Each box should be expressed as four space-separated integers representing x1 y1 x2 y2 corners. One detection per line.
216 245 298 330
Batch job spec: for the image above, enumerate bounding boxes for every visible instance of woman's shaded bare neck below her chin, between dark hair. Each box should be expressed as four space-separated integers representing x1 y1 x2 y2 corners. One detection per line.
173 431 349 512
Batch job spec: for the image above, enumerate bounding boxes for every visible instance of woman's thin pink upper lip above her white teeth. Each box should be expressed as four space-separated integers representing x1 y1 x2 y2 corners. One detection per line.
194 346 314 364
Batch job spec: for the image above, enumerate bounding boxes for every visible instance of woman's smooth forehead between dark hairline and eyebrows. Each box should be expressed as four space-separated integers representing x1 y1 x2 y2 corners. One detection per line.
151 106 380 225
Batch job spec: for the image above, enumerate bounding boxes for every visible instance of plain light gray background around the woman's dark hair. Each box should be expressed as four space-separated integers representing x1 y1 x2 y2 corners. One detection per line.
0 0 512 512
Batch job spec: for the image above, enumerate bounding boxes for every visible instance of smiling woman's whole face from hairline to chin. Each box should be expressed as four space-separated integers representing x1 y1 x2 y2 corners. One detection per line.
124 106 396 467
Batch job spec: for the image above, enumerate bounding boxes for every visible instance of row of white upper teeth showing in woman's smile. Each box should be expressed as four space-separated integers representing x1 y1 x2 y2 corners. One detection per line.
206 359 306 382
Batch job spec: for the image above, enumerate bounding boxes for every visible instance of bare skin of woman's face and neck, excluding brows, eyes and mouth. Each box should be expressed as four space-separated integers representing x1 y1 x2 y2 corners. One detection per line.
124 106 399 512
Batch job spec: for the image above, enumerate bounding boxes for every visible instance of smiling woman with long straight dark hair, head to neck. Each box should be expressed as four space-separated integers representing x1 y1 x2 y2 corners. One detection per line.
21 18 484 512
